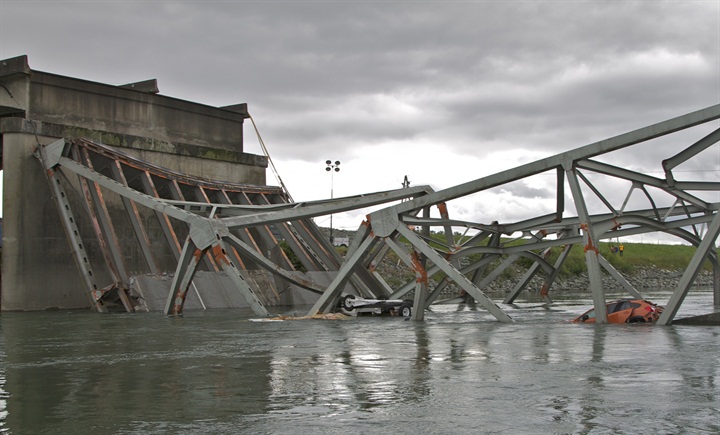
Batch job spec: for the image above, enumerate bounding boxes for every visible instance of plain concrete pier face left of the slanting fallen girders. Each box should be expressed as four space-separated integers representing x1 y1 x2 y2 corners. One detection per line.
1 131 98 310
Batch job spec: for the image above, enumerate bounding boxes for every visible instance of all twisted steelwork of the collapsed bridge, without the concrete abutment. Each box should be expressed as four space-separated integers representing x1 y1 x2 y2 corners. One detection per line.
33 105 720 324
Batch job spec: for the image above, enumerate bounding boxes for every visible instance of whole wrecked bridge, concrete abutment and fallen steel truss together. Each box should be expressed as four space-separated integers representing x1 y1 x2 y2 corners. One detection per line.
0 56 720 324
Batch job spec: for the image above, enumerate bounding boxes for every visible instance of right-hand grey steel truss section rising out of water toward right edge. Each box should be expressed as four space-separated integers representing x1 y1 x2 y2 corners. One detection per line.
309 105 720 324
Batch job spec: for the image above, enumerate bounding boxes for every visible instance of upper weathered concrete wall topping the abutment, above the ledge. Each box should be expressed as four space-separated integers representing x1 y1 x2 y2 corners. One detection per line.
0 57 247 152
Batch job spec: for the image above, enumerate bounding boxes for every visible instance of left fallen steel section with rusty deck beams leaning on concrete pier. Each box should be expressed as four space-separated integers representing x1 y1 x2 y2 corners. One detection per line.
36 139 431 315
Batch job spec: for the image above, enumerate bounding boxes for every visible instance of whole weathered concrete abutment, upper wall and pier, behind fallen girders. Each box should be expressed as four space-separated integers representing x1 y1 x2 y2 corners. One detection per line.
0 56 267 310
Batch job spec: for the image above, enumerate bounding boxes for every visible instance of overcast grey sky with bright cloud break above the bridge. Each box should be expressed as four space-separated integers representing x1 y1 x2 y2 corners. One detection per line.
0 0 720 240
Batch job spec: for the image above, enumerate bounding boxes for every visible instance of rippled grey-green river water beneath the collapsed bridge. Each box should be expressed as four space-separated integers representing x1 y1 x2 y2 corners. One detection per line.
0 292 720 434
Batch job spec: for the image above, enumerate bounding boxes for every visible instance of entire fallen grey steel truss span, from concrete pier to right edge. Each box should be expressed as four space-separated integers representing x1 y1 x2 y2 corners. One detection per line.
36 105 720 325
